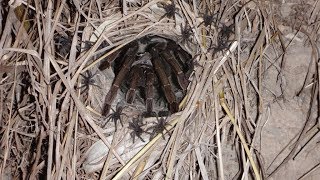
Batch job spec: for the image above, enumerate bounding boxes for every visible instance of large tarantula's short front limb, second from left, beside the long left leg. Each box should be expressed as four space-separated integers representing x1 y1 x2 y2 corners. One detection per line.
126 65 143 104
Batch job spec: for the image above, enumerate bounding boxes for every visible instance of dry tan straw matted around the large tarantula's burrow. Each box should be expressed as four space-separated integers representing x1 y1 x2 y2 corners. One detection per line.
0 0 318 179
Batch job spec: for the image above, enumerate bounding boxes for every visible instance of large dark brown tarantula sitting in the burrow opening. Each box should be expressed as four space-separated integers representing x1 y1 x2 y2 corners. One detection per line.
101 36 192 116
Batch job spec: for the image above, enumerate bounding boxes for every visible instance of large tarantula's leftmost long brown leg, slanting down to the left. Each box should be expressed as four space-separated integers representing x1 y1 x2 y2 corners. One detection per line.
102 44 138 116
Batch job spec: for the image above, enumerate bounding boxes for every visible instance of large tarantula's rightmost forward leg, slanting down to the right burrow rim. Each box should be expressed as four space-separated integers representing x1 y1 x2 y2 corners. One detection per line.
160 51 189 91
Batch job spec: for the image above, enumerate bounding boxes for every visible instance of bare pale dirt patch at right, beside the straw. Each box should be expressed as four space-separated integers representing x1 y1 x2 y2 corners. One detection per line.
255 21 320 179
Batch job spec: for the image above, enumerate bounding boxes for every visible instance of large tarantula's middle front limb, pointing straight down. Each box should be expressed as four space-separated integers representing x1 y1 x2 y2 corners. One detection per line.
145 68 155 114
